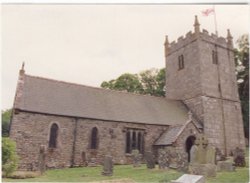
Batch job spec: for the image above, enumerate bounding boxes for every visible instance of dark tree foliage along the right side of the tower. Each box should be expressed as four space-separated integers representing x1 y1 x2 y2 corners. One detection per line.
235 34 249 138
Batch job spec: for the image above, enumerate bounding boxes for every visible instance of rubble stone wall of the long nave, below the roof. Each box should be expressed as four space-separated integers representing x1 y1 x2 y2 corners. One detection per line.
10 111 168 170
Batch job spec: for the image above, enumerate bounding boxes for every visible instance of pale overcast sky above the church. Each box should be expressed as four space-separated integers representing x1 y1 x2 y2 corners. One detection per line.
1 4 250 109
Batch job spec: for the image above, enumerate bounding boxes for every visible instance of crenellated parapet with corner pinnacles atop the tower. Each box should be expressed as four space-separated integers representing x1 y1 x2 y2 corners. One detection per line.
164 16 233 56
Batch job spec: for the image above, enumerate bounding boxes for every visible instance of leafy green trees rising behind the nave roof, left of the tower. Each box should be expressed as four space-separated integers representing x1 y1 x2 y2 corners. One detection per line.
101 69 165 96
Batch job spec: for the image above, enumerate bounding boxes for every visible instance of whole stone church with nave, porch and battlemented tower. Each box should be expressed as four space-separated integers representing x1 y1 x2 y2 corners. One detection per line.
10 17 245 170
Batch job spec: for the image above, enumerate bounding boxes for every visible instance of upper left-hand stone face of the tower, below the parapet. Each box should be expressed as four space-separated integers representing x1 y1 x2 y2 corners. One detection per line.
166 40 201 100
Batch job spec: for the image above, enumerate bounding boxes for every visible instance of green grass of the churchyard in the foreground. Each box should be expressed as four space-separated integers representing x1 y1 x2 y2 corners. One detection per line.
3 165 249 183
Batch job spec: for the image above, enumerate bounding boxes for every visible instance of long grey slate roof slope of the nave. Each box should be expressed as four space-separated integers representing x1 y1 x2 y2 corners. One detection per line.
15 74 188 125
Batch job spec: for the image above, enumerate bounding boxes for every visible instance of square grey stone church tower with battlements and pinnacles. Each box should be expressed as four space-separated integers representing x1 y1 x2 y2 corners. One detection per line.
164 16 245 155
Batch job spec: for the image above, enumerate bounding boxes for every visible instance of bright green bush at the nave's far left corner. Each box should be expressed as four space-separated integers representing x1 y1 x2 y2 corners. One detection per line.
2 137 18 177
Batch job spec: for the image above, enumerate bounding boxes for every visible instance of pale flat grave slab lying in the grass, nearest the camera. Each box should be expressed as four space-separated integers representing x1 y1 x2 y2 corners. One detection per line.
171 174 206 183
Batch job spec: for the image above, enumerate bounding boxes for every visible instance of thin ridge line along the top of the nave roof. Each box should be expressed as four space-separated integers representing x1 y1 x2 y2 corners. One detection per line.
25 74 176 101
